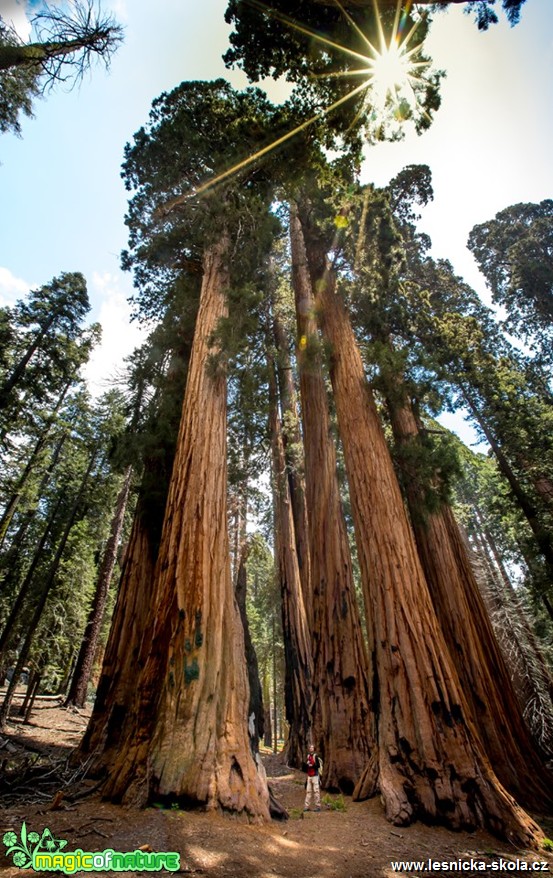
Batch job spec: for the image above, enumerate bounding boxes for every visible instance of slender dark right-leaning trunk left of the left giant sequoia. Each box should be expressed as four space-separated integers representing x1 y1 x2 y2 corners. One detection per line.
65 466 133 707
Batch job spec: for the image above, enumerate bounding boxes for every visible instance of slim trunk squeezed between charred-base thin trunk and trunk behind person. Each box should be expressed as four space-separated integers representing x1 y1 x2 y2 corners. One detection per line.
273 314 313 625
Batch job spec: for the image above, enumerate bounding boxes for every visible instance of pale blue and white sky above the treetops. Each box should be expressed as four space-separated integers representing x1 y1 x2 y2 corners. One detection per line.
0 0 553 440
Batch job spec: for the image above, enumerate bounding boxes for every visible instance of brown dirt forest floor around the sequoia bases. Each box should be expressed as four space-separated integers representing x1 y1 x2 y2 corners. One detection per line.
0 700 553 878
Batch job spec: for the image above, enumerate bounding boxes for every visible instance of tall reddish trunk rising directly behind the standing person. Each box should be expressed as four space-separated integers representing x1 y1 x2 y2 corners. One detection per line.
290 205 375 793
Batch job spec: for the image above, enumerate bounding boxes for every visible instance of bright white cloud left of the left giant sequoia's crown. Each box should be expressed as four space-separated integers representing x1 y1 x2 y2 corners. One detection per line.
83 272 147 396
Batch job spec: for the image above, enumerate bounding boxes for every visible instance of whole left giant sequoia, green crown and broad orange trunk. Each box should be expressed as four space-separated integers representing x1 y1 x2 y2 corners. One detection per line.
81 81 280 817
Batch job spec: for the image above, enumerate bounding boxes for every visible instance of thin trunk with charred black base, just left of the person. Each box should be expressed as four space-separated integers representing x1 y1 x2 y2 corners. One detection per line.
267 344 313 768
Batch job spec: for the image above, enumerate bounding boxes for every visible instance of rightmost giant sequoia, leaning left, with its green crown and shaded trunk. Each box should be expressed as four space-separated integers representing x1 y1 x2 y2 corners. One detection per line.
344 177 547 807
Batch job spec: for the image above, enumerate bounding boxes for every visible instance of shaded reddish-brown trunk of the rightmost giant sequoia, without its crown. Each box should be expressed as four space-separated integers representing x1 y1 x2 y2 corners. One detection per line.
387 375 553 810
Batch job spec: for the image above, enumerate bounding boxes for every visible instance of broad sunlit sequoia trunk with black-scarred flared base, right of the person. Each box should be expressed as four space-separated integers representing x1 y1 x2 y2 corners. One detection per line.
308 223 542 845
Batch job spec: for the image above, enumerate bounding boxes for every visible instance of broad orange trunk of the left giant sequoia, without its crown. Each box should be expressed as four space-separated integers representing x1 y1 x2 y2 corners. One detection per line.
98 236 269 819
